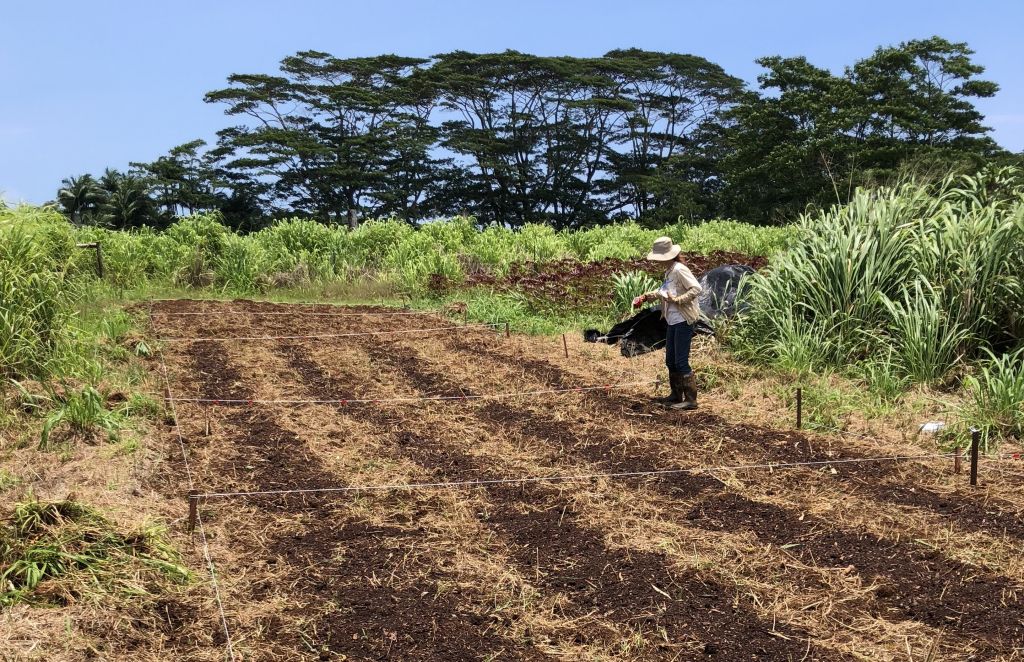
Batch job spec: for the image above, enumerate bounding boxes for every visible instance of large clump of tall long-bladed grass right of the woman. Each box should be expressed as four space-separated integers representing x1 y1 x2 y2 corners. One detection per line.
734 169 1024 384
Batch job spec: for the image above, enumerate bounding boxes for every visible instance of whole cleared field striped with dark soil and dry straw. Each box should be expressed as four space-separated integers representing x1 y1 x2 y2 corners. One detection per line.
9 301 1024 661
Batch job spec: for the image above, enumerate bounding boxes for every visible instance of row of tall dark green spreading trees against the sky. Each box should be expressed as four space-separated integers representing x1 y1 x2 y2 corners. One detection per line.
57 37 1007 229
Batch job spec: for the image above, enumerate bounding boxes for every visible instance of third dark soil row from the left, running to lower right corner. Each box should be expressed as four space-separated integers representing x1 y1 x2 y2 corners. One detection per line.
369 334 1024 652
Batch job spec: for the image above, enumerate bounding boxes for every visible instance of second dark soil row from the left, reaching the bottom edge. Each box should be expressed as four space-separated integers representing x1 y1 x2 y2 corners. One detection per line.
296 342 827 660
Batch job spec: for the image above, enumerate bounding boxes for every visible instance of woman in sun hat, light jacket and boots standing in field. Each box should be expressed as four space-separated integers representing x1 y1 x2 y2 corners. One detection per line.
633 237 700 410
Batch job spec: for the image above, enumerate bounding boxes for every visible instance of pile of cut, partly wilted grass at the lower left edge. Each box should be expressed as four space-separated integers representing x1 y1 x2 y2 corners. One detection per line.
0 499 188 606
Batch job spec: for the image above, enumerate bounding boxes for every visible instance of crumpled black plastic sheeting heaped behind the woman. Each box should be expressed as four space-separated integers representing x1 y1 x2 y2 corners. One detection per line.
583 264 754 357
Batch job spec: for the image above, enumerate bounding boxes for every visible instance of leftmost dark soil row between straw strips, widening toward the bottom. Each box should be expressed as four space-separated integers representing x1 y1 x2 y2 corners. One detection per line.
179 342 520 660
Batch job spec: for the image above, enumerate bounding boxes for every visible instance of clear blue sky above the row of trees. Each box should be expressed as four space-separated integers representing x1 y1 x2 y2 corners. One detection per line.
0 0 1024 203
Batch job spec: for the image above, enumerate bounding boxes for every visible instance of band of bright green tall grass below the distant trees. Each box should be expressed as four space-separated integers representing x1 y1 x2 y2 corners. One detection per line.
6 208 795 296
